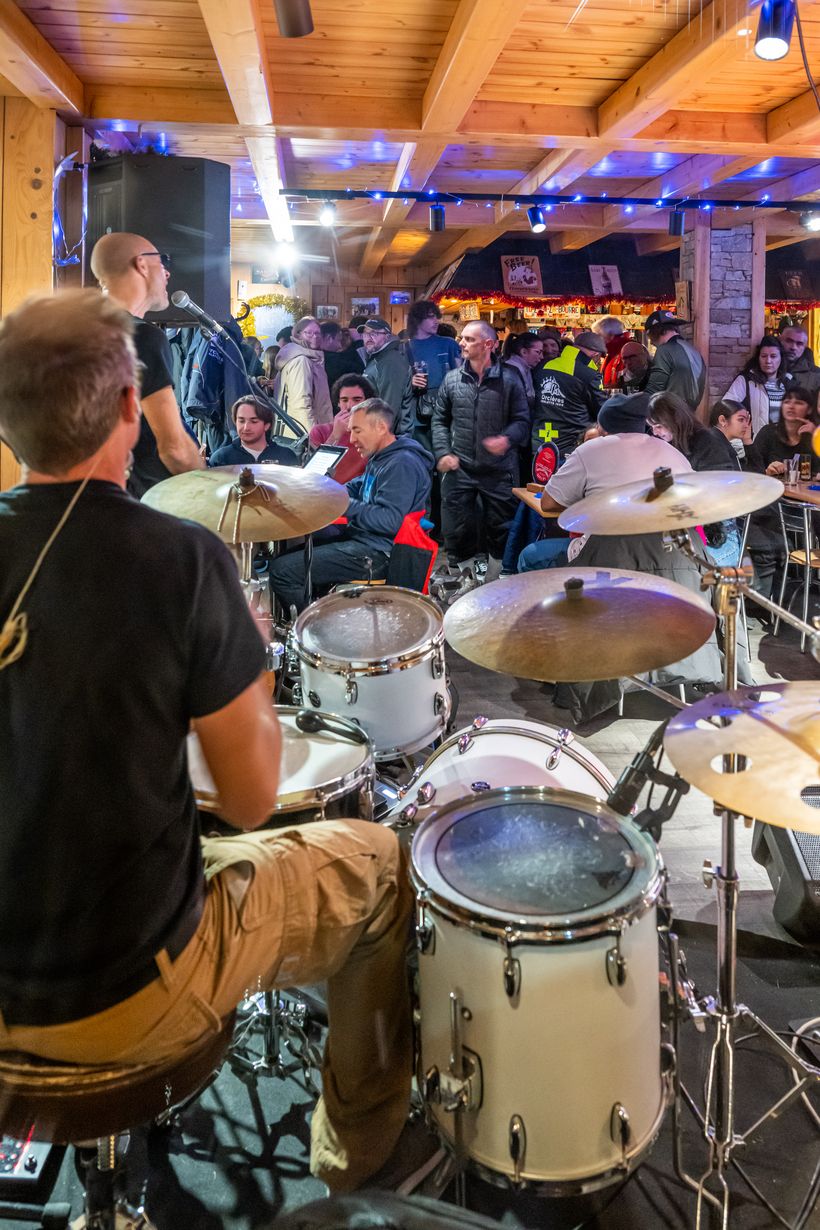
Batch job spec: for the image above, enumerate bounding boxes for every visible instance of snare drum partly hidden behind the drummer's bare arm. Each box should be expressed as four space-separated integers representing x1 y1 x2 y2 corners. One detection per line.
188 705 374 828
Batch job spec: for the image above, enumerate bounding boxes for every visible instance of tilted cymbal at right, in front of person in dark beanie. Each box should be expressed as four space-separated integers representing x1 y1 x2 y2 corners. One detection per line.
558 470 783 534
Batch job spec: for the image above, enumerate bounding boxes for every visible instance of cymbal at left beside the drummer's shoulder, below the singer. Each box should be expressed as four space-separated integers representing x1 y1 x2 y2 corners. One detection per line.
143 464 349 542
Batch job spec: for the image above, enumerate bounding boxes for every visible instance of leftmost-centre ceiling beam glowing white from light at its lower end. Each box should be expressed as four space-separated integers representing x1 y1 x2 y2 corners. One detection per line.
199 0 294 242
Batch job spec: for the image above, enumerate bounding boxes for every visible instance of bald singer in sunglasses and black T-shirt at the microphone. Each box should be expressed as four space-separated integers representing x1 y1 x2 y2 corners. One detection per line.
91 231 205 499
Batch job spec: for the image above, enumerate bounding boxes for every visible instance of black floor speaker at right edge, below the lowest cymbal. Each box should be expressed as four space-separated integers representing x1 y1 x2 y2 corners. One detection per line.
751 786 820 947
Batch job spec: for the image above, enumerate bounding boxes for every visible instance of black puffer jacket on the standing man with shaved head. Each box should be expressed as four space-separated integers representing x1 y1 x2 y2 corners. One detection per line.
433 363 530 476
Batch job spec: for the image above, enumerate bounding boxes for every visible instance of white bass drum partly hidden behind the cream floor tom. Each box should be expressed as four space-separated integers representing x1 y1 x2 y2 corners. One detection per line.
382 717 615 833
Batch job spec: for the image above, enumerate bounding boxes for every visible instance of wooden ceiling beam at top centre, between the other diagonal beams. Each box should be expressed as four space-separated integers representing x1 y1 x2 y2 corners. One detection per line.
422 0 522 133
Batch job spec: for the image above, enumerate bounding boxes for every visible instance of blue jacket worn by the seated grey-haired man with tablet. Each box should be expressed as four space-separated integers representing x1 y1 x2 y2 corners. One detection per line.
344 435 433 551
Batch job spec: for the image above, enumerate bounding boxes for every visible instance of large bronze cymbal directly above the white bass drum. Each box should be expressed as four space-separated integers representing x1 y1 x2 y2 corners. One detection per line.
444 567 714 683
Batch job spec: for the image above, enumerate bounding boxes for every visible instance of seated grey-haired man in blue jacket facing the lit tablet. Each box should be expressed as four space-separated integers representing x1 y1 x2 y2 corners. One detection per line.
270 397 433 613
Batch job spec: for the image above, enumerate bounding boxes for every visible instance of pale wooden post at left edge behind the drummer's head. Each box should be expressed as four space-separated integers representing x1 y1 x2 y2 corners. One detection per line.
0 98 57 490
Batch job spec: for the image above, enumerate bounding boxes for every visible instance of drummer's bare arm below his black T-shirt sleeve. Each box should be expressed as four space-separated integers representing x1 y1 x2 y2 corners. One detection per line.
193 677 282 829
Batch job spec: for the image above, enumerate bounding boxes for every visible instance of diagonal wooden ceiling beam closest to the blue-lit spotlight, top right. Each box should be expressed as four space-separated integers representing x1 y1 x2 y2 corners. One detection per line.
597 0 749 140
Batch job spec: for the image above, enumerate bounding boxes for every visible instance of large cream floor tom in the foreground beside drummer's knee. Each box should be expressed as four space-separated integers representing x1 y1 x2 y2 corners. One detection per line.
412 788 669 1194
